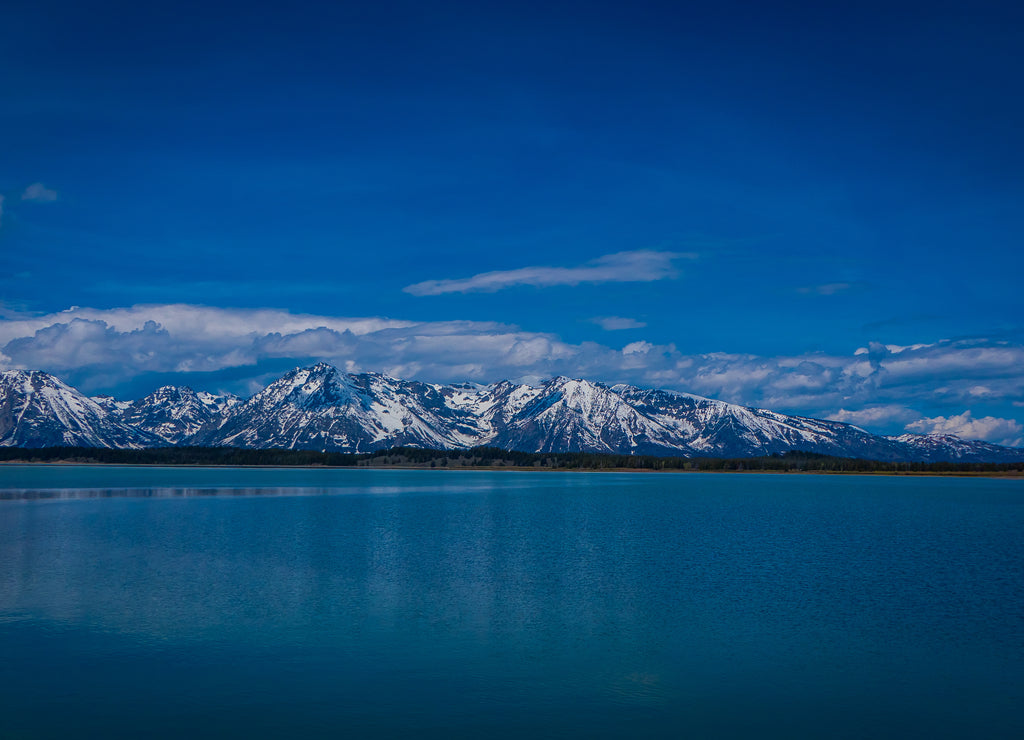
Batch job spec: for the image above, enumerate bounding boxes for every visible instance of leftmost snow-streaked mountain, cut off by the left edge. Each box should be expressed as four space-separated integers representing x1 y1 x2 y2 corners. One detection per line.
0 371 164 448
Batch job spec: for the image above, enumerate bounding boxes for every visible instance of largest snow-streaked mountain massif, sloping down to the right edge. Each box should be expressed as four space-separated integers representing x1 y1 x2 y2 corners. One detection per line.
191 363 1024 461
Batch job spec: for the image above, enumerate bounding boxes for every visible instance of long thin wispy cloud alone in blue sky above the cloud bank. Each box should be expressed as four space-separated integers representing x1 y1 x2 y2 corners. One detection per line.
403 250 696 296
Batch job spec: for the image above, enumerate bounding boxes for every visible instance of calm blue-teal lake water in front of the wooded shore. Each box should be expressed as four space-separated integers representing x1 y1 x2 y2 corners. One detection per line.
0 466 1024 740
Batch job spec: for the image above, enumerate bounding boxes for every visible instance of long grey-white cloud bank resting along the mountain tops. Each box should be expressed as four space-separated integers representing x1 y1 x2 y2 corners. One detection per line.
0 304 1024 443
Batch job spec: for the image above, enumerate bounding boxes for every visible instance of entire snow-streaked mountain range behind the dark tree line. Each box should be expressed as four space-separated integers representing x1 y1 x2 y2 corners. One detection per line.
0 363 1024 462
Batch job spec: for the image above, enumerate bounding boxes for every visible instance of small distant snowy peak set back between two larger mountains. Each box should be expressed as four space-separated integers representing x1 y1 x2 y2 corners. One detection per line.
108 386 242 444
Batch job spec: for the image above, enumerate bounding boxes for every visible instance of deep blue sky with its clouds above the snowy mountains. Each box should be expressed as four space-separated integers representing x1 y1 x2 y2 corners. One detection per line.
0 2 1024 444
